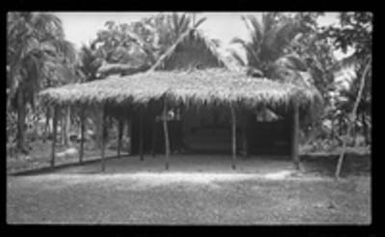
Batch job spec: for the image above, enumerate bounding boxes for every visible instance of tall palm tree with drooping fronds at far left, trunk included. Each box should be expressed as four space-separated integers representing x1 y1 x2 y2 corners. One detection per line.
7 12 75 152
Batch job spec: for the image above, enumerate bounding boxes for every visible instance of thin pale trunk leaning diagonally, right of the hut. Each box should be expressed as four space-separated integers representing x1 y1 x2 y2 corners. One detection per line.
335 57 372 179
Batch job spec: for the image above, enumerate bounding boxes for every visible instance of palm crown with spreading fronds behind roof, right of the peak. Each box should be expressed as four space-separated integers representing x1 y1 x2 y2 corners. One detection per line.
232 13 306 79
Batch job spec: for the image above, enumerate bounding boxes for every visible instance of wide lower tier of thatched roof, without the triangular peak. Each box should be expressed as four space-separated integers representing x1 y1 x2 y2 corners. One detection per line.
40 69 320 112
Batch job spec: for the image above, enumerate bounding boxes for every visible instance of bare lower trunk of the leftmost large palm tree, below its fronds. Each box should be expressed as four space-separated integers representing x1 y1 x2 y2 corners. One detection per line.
17 91 27 153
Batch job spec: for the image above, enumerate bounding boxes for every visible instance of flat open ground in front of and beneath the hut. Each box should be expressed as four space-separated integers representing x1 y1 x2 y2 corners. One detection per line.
7 156 371 225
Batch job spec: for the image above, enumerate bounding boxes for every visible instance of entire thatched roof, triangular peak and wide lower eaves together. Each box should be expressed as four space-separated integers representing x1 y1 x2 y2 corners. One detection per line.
40 26 322 118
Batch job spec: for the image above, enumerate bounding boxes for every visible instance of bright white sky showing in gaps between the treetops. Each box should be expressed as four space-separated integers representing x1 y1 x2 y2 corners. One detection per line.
54 12 341 57
